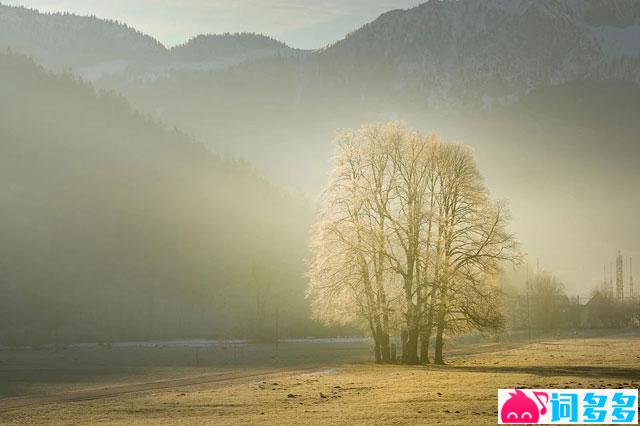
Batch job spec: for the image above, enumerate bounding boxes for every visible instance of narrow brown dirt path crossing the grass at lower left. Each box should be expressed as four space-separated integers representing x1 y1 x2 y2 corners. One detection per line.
0 368 318 412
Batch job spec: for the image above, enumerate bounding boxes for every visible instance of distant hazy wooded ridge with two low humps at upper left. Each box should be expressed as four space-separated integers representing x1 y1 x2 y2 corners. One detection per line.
0 4 294 81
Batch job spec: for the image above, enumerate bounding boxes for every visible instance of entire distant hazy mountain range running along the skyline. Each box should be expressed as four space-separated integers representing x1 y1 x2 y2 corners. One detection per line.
0 0 640 104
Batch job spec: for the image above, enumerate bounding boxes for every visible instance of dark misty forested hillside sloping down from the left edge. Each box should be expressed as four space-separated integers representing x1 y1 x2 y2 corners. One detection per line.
0 54 320 344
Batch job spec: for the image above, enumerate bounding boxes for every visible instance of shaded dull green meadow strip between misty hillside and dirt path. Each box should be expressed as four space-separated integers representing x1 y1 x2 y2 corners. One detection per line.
0 340 370 400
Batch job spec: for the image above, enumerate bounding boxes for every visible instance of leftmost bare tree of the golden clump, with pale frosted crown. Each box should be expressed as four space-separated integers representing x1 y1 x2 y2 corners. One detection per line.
307 128 393 362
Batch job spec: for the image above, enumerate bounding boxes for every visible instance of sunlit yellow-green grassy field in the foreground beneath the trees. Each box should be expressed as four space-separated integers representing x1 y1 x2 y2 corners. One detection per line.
0 335 640 425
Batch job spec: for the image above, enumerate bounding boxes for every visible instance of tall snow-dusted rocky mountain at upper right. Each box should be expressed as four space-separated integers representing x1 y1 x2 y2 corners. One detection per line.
318 0 640 107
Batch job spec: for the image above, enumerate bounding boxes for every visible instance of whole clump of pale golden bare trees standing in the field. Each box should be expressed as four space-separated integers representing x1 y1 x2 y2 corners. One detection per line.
307 123 519 364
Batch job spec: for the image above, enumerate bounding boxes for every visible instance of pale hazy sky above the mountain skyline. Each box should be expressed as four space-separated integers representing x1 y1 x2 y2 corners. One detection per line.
0 0 424 48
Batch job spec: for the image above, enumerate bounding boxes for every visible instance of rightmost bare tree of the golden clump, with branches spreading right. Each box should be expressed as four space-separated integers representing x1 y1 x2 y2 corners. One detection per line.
428 144 520 363
